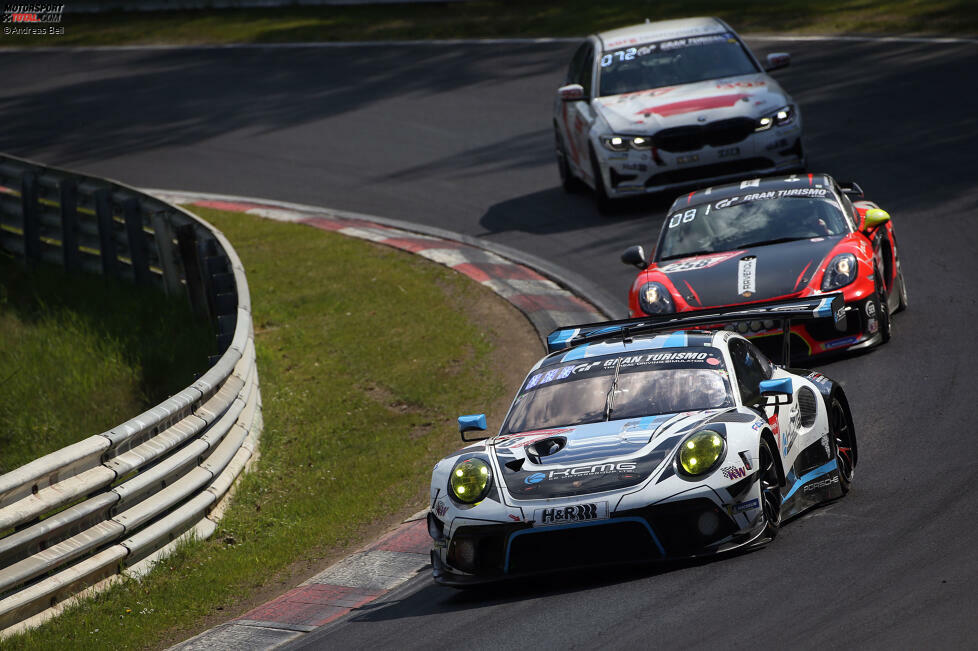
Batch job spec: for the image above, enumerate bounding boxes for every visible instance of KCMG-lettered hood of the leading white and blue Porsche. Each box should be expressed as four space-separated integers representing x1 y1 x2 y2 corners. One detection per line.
490 409 728 500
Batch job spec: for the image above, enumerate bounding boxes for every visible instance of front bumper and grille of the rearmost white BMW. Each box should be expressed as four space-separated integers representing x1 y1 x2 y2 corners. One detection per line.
594 125 805 198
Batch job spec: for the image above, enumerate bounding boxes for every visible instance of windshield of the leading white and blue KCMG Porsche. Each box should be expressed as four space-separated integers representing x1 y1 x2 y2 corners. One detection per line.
501 346 734 434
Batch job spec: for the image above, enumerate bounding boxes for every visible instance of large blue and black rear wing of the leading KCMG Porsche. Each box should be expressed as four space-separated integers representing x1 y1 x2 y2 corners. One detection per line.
547 293 846 365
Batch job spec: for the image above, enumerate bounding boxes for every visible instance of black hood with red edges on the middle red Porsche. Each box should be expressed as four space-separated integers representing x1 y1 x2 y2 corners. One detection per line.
645 235 844 308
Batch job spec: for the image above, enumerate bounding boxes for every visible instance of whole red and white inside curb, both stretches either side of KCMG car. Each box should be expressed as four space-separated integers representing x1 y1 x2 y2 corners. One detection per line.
147 190 607 651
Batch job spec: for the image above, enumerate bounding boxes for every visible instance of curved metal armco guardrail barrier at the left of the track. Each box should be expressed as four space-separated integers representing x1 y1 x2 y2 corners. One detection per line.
0 155 262 637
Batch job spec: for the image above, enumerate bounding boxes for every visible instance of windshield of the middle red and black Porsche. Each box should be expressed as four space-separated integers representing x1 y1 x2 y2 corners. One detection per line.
657 188 848 260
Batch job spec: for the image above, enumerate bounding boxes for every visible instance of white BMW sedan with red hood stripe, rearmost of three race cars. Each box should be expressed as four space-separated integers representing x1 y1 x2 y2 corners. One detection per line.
554 18 805 210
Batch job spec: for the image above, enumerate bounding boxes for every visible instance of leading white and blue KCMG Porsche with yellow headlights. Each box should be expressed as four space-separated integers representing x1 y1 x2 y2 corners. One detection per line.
427 294 856 586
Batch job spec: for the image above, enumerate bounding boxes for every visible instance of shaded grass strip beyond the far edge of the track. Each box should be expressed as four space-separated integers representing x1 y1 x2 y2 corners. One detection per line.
0 0 978 45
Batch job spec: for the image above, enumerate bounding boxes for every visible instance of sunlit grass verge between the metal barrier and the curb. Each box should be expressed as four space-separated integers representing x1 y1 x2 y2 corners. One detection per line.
4 209 542 649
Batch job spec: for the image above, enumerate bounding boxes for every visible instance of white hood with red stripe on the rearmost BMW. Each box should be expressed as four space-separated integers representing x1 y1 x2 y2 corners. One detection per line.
592 73 790 135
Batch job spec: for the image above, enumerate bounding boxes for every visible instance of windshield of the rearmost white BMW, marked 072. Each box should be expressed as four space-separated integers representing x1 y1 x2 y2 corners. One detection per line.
598 33 758 97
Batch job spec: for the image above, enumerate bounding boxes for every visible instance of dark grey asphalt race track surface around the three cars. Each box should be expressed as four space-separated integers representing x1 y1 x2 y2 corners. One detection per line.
0 39 978 648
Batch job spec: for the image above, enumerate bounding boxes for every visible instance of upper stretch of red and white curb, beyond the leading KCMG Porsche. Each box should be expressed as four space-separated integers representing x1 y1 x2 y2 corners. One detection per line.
147 190 607 337
